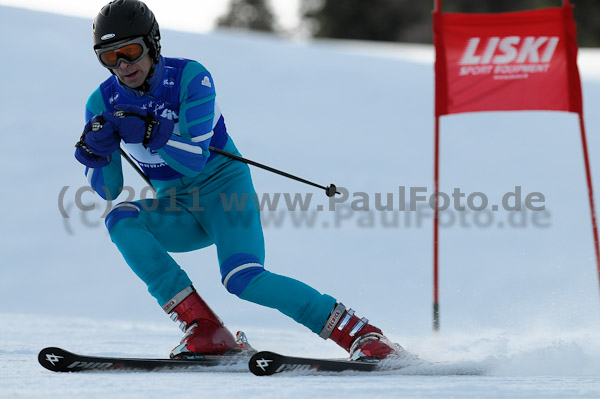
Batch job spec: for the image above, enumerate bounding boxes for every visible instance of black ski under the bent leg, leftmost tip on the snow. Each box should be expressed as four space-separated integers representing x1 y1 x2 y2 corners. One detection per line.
38 347 249 372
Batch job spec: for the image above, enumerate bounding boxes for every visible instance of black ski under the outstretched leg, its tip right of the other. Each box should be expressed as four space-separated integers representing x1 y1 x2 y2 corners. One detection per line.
248 351 377 376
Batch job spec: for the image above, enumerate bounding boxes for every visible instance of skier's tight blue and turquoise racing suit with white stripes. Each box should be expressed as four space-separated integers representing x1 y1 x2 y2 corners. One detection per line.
85 56 336 333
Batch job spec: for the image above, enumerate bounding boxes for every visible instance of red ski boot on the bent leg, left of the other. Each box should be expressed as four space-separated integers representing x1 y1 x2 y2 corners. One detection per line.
163 286 242 359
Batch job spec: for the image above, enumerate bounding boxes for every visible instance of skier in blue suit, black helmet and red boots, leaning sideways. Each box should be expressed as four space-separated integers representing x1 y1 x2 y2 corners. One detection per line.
75 0 403 360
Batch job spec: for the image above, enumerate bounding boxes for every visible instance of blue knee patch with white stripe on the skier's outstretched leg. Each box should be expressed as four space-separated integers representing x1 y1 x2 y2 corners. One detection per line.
221 254 265 296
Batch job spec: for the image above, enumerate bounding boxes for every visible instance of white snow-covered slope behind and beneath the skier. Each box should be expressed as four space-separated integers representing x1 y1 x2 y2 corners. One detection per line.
0 7 600 398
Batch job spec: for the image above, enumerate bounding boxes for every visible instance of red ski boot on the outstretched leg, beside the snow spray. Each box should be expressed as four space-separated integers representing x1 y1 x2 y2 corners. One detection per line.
319 303 405 361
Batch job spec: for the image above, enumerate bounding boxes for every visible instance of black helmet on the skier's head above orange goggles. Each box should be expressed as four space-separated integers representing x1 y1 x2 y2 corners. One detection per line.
93 0 160 64
